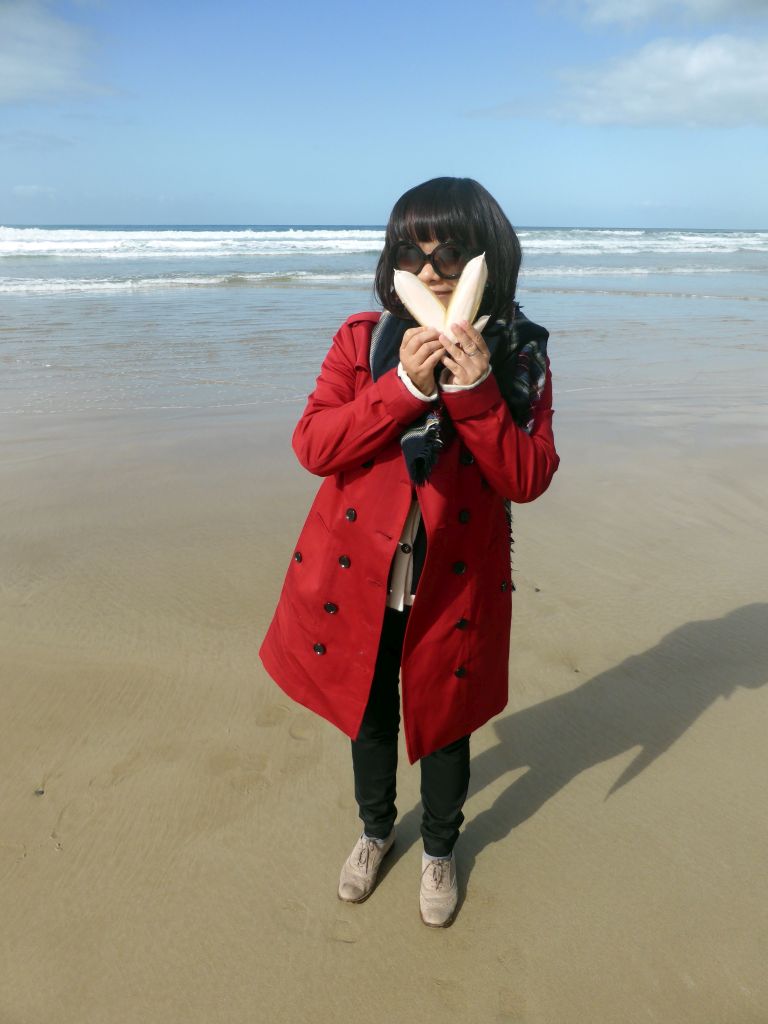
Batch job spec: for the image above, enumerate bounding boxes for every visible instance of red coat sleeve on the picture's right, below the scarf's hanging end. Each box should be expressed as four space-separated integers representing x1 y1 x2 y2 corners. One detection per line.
443 359 560 502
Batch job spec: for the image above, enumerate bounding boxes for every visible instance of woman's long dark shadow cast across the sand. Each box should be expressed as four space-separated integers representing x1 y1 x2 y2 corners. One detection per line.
398 604 768 909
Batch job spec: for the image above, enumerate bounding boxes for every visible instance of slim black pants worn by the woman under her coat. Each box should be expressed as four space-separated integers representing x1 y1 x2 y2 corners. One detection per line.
352 608 469 857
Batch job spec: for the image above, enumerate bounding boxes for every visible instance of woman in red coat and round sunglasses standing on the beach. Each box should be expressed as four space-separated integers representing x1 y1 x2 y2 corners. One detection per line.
260 177 559 927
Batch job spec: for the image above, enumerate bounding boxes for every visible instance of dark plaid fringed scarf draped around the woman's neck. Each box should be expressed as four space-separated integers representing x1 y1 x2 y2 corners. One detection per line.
370 304 549 485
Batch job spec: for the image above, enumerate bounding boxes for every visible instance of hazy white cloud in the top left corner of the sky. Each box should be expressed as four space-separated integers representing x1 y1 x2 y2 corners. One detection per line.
0 0 94 103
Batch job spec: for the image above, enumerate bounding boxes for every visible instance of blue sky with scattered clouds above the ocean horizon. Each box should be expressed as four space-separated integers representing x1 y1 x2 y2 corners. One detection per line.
0 0 768 228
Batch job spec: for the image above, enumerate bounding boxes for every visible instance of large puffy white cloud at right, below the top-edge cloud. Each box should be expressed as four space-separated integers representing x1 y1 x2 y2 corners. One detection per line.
557 36 768 126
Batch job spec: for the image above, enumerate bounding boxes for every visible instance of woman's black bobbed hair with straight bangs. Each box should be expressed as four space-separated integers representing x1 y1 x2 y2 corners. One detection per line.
374 177 522 319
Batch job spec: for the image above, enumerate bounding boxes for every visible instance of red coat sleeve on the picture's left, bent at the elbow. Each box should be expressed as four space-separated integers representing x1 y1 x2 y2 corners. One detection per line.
293 319 436 476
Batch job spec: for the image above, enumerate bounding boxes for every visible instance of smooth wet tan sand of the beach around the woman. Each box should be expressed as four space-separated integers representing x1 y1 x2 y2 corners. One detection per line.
0 401 768 1024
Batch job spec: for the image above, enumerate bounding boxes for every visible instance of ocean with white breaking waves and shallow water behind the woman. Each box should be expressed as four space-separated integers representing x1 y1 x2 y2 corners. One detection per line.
0 225 768 436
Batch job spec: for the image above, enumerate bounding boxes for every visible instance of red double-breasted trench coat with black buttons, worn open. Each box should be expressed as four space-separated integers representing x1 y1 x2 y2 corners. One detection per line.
259 313 559 763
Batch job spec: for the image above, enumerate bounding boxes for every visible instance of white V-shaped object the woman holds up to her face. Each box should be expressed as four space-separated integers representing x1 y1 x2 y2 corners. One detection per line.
394 253 488 342
